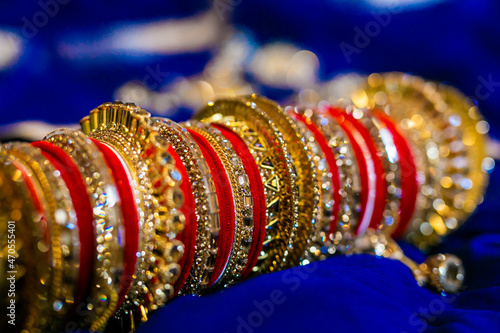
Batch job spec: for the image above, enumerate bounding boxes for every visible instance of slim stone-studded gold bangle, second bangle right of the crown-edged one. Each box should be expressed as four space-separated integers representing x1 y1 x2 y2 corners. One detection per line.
152 118 220 295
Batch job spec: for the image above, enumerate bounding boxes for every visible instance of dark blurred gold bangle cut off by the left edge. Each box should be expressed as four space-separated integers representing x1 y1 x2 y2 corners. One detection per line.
0 154 45 332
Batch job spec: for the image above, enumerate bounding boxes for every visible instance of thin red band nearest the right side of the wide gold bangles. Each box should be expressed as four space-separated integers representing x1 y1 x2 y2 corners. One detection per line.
290 112 342 240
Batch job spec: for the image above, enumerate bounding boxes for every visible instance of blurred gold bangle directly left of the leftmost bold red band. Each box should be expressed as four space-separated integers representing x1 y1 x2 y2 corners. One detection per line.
2 143 80 330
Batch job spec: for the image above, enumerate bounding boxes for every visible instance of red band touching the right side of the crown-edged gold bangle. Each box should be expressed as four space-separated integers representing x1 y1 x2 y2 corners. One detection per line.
168 147 198 295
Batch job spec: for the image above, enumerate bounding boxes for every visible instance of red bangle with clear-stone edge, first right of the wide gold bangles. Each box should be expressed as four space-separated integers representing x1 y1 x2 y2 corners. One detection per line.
286 107 341 261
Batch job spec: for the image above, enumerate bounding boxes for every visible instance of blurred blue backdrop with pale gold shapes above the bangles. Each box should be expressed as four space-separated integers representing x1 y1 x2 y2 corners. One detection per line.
0 0 500 139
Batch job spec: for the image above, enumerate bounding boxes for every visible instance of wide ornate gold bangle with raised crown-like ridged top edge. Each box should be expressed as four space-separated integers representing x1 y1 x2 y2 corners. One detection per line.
80 102 184 325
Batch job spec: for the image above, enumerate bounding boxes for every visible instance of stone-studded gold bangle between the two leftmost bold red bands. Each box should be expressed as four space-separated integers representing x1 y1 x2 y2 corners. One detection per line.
44 130 123 331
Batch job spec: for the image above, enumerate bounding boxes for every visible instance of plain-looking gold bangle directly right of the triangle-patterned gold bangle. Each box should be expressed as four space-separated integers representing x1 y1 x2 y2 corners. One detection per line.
244 95 319 268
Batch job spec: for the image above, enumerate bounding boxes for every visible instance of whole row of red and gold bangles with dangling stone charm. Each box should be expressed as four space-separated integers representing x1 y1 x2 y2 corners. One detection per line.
0 73 494 332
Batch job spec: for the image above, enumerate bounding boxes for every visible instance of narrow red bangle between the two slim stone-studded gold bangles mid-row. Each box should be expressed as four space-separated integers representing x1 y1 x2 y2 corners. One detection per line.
188 129 235 287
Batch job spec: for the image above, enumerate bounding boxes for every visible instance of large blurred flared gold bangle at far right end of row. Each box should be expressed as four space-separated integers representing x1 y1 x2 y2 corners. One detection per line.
352 73 494 250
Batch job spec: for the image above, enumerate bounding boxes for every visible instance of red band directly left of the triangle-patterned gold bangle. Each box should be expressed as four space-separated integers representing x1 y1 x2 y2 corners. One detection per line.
212 124 267 279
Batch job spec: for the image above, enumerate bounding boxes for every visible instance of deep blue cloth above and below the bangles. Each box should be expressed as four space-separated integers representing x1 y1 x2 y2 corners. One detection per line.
0 0 500 333
